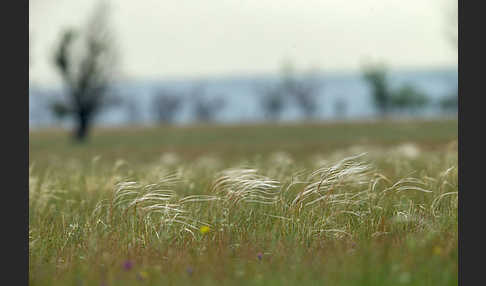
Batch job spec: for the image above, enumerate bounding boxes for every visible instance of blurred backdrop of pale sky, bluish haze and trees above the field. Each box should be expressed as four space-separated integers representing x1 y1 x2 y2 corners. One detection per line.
29 0 458 140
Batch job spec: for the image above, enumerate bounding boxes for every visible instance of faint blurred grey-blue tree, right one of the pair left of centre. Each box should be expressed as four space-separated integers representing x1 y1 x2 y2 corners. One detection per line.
191 85 225 122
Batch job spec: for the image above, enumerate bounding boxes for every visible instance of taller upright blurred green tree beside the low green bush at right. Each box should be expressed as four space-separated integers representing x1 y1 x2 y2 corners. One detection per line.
363 64 391 116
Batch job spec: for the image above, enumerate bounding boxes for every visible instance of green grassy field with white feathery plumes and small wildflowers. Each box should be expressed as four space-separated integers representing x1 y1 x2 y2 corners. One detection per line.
29 120 458 286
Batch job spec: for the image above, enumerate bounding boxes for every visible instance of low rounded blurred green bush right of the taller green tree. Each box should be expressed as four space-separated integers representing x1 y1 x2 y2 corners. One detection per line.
391 84 428 113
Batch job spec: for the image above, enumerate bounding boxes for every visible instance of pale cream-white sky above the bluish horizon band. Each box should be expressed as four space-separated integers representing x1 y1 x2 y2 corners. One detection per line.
29 0 457 85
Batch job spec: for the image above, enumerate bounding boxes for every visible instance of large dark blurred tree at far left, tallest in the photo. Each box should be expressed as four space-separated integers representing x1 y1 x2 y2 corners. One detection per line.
52 2 115 141
